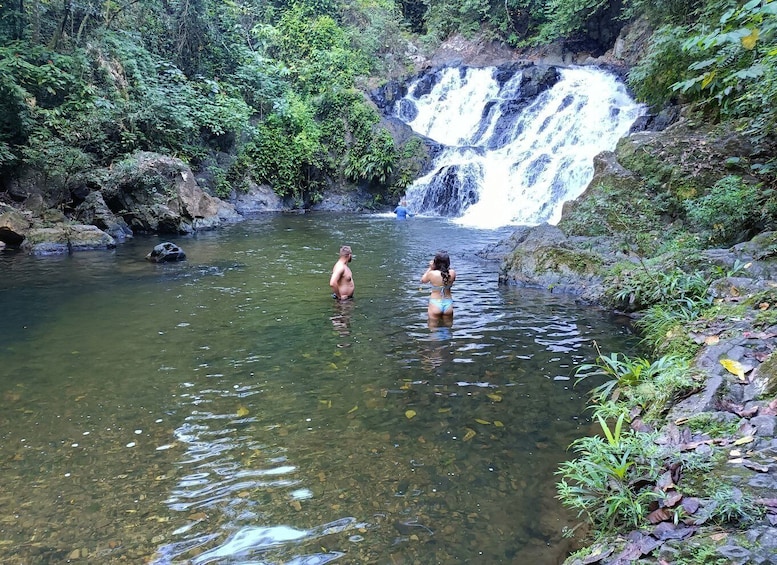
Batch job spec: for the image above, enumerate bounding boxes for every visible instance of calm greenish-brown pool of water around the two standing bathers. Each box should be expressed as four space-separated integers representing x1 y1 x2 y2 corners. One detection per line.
0 214 634 565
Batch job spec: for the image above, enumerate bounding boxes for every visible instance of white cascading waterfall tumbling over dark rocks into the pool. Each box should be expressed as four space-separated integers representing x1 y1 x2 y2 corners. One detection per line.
393 67 645 228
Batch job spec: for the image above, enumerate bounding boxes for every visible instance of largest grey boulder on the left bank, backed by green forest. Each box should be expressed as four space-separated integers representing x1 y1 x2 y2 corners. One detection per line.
103 152 240 234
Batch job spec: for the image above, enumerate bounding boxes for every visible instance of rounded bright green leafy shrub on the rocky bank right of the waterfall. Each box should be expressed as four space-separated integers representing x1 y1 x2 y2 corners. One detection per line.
684 176 761 244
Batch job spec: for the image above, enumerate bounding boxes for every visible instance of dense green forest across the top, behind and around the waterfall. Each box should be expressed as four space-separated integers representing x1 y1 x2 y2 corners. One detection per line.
0 0 777 207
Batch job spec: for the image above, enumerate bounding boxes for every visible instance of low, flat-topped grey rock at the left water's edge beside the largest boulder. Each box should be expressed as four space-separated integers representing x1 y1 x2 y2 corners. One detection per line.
21 224 116 255
